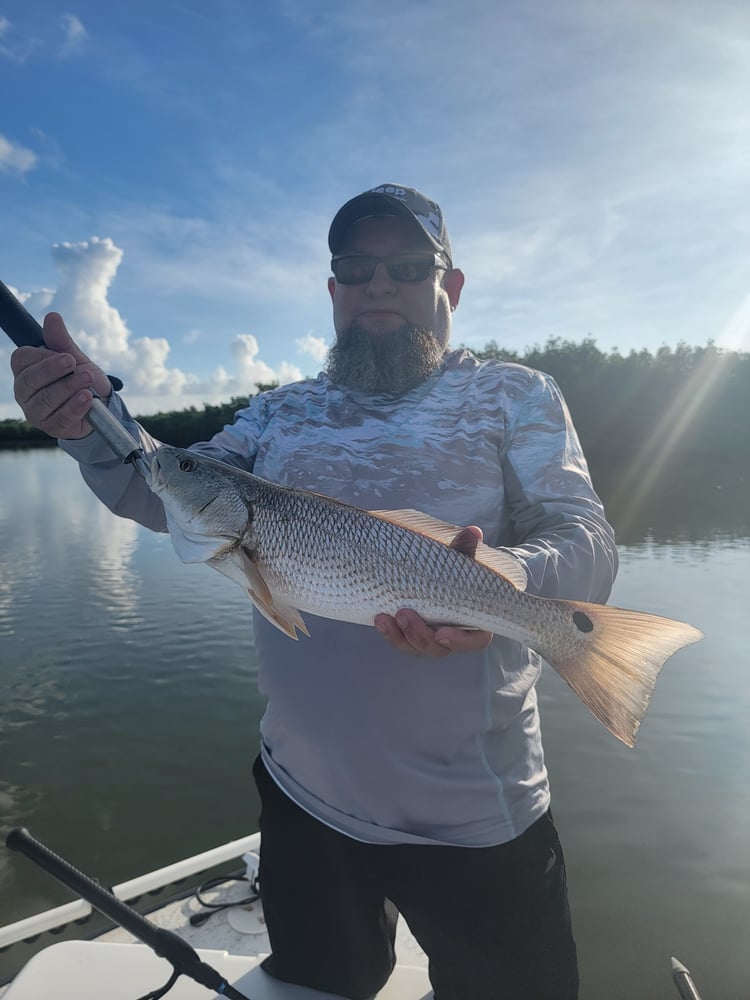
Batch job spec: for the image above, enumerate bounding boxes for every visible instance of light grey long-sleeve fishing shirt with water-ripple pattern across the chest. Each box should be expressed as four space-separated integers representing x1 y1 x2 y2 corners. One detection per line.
61 350 617 847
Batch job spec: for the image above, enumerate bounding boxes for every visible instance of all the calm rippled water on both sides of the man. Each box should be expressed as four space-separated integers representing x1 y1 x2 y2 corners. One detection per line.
0 450 750 1000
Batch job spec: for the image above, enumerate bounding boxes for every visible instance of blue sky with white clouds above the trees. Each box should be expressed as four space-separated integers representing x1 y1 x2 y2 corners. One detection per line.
0 0 750 419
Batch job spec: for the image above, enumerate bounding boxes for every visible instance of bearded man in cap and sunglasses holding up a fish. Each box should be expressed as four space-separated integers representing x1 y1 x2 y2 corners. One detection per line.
12 185 617 1000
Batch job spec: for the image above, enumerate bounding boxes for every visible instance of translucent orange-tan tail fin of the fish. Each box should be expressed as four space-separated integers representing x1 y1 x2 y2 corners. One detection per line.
538 601 703 747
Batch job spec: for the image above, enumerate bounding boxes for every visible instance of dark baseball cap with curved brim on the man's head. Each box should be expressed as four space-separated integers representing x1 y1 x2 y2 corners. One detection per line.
328 184 453 267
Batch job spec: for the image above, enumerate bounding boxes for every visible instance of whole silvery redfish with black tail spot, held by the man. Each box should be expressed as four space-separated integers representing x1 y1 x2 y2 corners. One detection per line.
151 445 702 746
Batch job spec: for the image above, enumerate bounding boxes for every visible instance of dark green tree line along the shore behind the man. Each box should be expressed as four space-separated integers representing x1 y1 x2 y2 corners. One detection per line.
0 338 750 541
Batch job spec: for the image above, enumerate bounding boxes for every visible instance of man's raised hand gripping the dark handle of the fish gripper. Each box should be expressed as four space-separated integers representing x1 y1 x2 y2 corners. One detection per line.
10 313 112 438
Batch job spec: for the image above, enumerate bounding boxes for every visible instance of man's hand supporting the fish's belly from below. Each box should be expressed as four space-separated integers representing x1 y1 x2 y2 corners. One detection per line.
375 524 493 657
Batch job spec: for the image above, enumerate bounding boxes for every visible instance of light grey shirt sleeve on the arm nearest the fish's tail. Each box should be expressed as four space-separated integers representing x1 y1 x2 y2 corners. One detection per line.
501 372 617 603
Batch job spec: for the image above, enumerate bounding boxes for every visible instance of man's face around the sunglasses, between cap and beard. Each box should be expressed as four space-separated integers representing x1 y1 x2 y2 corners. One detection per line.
328 216 463 348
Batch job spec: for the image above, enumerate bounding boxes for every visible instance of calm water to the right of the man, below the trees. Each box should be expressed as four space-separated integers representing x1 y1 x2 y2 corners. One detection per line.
541 532 750 1000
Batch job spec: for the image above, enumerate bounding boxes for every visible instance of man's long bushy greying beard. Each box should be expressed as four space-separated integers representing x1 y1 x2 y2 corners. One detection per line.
326 321 446 396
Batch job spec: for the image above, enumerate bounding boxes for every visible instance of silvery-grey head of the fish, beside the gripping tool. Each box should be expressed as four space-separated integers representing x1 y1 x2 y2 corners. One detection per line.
151 445 254 562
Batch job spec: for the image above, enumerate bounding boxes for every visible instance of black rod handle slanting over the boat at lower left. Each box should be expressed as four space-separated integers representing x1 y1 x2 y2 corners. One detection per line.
5 827 253 1000
